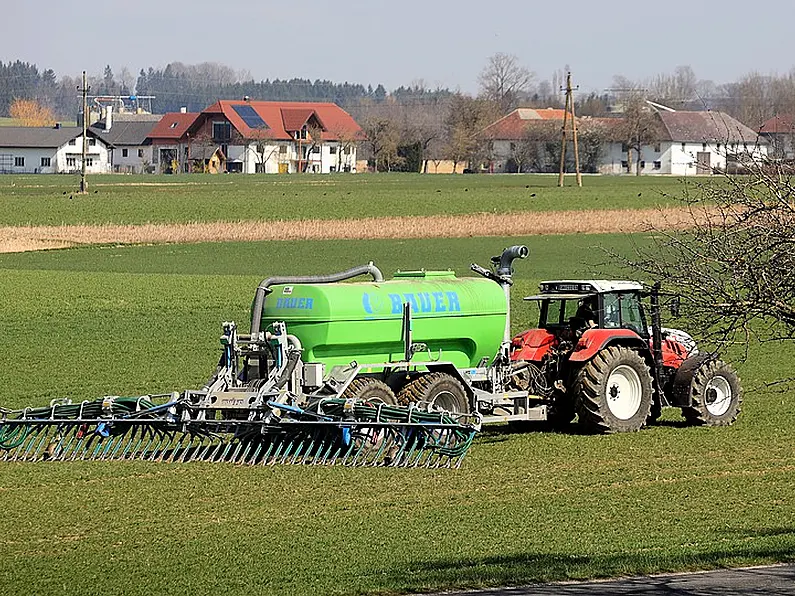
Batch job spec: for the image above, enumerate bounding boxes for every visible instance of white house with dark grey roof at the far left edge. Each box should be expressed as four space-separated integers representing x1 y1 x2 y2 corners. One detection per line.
0 124 110 174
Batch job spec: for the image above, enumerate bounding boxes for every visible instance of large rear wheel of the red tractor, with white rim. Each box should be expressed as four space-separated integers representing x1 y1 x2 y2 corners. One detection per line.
574 346 652 433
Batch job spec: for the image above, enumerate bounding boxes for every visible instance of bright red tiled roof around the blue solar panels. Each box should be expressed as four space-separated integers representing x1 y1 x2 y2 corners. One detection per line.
203 100 363 141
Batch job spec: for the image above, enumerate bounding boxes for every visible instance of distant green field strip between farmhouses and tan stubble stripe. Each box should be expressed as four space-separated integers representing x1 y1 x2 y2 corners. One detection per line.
0 174 684 225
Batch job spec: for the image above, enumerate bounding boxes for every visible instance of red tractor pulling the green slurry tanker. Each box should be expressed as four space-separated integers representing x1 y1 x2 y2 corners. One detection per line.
510 280 742 432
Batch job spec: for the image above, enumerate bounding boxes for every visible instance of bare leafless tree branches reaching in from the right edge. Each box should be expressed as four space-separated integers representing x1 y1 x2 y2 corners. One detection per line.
629 163 795 364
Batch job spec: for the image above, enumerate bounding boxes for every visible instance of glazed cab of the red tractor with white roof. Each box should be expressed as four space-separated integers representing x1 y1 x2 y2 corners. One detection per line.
525 280 649 338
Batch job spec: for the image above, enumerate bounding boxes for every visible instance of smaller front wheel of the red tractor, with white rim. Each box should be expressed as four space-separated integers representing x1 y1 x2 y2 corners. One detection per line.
674 359 743 426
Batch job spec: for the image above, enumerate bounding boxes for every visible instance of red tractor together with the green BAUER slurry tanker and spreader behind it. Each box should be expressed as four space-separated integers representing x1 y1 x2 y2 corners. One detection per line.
0 246 742 467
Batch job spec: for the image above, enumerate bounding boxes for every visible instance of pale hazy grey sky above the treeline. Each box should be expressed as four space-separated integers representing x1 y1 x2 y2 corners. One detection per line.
6 0 795 93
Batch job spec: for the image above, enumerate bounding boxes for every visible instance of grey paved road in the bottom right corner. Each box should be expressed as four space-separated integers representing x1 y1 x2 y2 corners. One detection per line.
430 565 795 596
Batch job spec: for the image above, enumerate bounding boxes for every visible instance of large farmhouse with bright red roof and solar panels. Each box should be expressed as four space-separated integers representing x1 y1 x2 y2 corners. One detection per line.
185 100 363 174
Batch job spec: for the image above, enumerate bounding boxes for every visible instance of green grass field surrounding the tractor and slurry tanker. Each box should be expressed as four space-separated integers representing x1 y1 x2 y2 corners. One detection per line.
0 236 795 594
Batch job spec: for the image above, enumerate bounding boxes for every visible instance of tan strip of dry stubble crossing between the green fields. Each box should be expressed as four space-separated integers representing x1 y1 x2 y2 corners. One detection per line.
0 208 693 252
